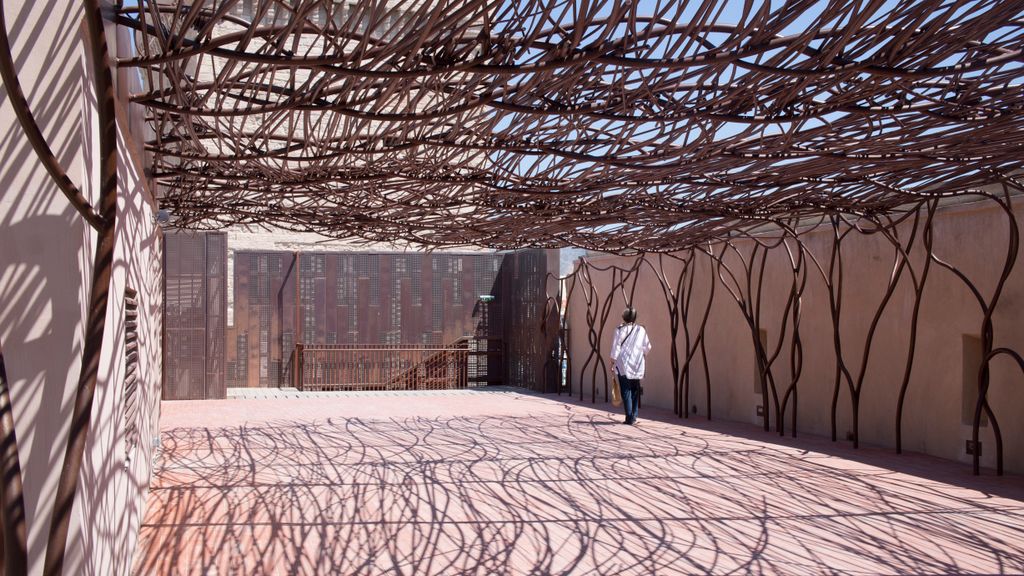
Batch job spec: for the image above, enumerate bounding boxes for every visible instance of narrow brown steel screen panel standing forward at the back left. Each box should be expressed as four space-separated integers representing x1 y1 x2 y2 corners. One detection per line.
163 233 227 400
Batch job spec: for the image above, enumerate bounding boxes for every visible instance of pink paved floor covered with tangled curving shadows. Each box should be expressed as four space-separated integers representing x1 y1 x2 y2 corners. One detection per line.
135 393 1024 576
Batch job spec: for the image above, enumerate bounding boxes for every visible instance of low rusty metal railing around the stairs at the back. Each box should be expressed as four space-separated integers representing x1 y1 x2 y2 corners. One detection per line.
295 340 471 390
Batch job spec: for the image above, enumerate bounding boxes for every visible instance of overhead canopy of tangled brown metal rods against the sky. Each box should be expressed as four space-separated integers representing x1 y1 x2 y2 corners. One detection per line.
117 0 1024 252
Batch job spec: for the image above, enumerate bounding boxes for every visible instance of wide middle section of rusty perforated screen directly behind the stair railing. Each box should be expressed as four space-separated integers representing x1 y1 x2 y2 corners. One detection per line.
227 251 505 387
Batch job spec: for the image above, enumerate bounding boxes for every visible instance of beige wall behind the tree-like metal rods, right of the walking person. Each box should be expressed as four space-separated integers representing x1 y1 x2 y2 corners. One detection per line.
568 198 1024 474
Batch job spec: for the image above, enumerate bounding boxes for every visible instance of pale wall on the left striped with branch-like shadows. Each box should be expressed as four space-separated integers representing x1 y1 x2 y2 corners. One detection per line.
0 0 162 575
